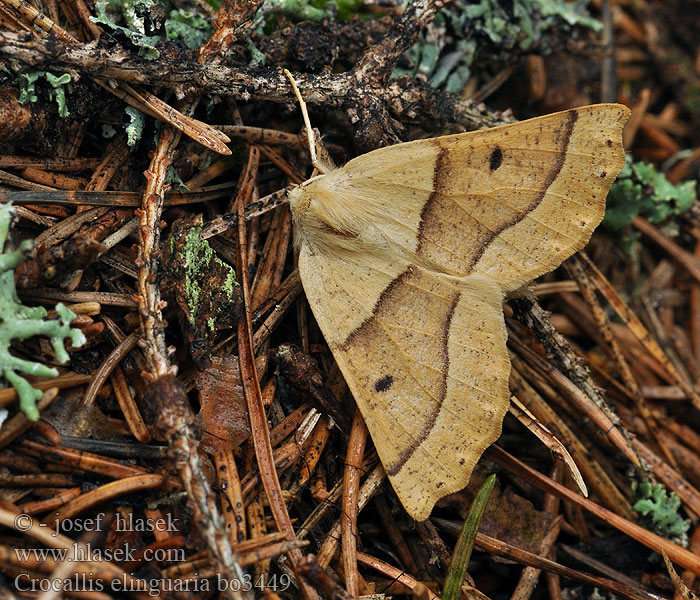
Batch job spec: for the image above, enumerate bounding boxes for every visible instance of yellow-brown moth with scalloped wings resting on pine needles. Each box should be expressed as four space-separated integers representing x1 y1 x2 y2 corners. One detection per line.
289 88 629 520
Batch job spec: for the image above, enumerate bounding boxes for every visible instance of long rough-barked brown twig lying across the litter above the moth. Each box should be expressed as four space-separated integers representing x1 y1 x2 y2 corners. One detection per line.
0 27 508 149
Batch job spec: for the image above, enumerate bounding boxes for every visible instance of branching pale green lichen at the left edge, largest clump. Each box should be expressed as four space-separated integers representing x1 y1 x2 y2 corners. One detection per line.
0 204 85 421
